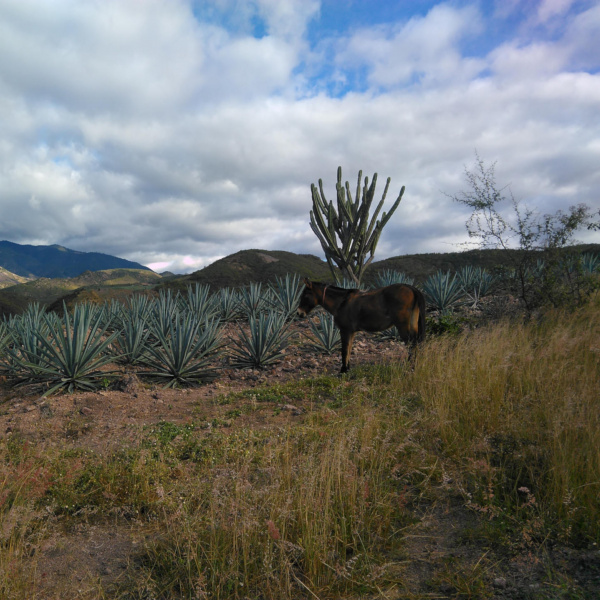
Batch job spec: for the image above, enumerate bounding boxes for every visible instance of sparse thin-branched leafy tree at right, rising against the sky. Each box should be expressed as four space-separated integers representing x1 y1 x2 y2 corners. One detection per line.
447 153 600 311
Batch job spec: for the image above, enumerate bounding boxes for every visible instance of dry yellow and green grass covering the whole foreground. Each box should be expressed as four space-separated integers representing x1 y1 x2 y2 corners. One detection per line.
0 276 600 600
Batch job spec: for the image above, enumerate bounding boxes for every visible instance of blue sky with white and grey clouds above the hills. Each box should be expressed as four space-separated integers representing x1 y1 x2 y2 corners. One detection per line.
0 0 600 273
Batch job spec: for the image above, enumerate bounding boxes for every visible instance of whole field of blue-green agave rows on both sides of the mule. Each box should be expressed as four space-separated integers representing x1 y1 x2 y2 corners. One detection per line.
0 255 600 394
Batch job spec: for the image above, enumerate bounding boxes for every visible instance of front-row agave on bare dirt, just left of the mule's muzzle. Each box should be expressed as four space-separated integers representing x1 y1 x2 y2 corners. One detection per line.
231 310 291 367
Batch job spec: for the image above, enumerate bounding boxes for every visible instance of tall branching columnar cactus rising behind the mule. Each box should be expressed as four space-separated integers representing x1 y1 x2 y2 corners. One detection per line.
310 167 404 286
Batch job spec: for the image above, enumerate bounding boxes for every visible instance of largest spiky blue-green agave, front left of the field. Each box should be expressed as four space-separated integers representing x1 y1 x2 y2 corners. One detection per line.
9 304 118 396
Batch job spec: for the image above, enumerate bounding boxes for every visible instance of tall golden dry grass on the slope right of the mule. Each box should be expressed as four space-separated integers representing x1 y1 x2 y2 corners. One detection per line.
399 303 600 539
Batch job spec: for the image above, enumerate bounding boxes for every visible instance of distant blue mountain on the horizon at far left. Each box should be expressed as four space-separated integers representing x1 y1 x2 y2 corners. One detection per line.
0 241 150 279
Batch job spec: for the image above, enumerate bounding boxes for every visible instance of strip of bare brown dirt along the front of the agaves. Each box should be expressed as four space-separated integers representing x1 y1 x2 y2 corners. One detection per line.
0 324 407 452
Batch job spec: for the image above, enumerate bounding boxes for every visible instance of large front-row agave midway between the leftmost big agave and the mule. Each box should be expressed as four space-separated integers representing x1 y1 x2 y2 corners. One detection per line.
140 312 221 388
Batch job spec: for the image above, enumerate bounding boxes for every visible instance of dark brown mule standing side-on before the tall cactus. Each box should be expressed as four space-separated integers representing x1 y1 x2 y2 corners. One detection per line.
298 279 425 373
